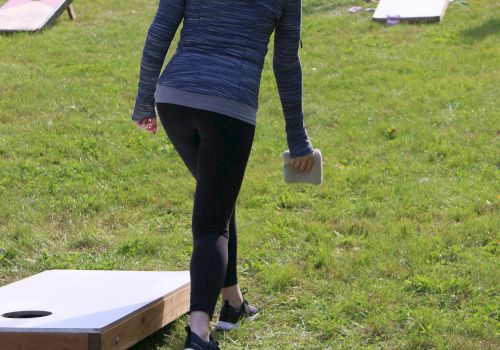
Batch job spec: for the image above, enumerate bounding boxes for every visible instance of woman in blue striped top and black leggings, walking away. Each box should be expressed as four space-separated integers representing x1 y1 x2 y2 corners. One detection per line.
132 0 314 350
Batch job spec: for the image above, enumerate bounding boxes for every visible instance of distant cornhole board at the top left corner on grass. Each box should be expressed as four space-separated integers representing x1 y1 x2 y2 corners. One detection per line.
0 0 73 32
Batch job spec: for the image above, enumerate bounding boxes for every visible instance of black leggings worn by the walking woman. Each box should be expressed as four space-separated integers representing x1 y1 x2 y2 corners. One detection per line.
157 103 255 318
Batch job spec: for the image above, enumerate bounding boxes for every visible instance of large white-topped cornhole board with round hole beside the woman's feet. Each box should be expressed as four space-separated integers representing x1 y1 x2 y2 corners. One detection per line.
0 270 191 350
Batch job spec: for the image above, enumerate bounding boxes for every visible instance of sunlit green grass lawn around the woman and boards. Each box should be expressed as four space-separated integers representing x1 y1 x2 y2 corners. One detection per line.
0 0 500 350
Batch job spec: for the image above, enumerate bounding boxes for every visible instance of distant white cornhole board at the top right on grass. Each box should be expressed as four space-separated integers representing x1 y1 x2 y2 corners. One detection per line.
373 0 449 22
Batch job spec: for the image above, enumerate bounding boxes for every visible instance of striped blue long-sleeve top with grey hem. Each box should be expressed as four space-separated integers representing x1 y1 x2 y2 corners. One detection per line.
132 0 313 157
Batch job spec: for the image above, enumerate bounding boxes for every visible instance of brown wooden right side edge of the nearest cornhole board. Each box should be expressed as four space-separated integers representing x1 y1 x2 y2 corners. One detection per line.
101 283 191 350
